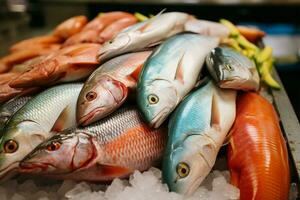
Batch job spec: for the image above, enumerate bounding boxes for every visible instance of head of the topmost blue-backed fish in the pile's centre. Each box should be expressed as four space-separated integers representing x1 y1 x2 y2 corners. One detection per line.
137 79 178 128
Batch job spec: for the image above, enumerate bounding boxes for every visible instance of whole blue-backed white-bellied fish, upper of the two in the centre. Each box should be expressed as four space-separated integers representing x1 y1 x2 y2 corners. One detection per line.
137 33 219 127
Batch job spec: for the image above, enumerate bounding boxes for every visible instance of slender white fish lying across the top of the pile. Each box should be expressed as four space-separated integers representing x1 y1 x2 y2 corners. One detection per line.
98 12 192 61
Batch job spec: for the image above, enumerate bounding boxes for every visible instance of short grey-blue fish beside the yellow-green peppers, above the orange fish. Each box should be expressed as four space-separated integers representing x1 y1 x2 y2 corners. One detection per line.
206 47 259 90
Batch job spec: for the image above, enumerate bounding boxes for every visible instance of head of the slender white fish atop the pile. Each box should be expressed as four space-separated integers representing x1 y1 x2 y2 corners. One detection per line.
98 32 136 62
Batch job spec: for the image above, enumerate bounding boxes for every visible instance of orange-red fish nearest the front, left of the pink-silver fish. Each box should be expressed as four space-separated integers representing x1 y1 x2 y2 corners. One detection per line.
9 43 101 88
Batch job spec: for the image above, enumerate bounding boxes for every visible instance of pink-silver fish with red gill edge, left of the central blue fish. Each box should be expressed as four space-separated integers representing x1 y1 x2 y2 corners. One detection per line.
76 51 151 126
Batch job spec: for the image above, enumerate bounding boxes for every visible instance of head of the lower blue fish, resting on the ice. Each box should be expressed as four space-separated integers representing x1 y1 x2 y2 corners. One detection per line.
162 135 217 196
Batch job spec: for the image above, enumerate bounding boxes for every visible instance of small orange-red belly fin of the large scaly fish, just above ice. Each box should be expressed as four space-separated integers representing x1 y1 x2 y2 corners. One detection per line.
97 164 132 177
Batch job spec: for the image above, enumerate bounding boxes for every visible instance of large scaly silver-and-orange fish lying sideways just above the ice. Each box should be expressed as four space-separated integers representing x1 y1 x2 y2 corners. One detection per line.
20 107 167 181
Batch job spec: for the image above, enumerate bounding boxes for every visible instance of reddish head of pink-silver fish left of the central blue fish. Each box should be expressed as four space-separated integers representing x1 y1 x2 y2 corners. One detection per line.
77 75 128 126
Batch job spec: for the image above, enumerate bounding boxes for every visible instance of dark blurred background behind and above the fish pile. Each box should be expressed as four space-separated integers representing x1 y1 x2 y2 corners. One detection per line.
0 0 300 119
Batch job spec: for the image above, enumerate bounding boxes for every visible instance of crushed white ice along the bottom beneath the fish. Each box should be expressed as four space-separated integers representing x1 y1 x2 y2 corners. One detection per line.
0 168 239 200
